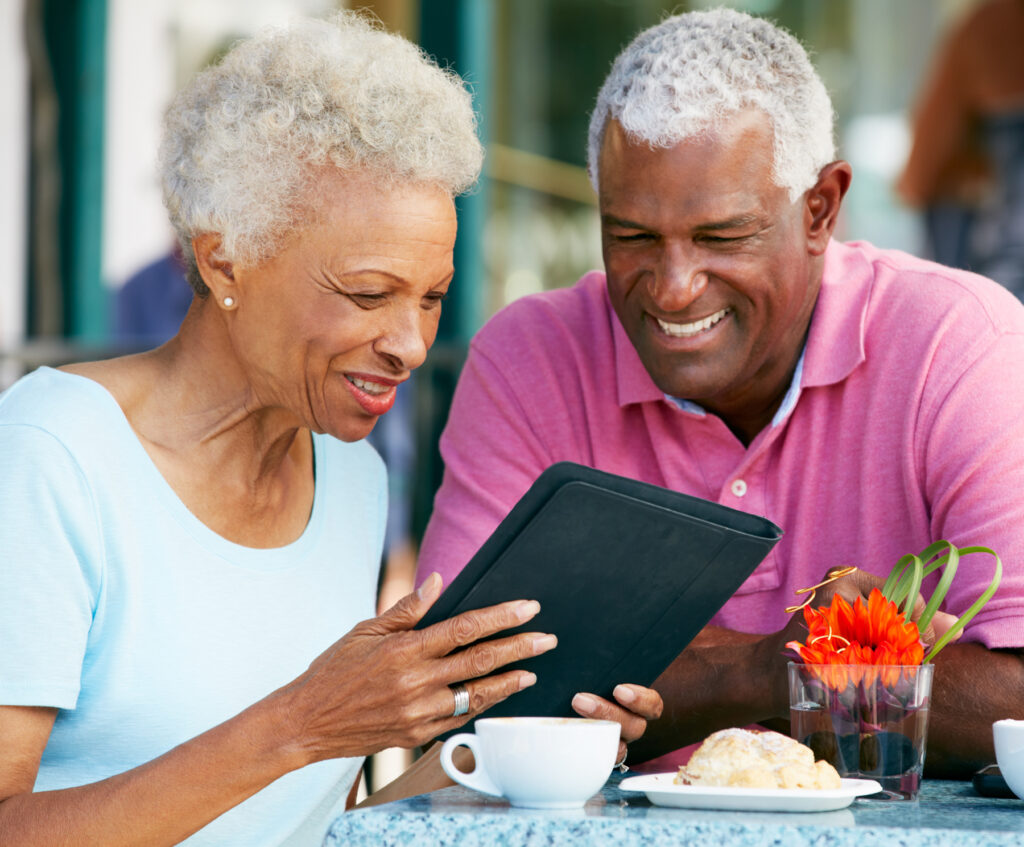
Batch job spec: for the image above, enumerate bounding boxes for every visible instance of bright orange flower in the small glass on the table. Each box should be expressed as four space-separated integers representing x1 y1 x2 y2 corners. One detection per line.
786 588 925 689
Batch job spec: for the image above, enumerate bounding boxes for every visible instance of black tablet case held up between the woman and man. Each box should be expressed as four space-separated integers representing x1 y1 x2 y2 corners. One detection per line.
417 462 782 737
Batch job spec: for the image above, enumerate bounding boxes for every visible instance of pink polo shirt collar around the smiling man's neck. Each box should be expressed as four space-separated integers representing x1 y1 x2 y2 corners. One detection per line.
604 241 871 417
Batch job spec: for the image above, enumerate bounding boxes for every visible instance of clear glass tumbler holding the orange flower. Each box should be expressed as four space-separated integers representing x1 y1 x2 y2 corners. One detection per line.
790 662 935 800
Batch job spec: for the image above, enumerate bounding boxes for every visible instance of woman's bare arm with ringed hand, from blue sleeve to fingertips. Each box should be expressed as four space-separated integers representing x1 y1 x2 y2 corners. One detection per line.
0 577 554 847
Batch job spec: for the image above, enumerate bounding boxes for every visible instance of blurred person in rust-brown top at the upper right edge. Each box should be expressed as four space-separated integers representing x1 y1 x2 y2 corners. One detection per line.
897 0 1024 298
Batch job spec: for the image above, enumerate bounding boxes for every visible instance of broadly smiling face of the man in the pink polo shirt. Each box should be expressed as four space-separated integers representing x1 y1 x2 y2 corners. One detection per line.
598 112 821 432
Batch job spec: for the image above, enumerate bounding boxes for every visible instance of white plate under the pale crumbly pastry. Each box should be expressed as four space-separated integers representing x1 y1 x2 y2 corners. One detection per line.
618 773 882 812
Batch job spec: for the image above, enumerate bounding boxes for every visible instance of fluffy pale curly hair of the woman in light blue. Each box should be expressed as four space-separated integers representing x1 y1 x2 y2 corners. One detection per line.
160 11 483 297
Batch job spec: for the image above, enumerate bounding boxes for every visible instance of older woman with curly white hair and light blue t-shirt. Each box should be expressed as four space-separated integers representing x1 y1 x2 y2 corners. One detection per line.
0 14 660 847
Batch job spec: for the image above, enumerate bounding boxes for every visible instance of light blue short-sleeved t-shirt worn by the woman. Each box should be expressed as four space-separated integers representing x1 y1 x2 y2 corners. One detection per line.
0 368 387 847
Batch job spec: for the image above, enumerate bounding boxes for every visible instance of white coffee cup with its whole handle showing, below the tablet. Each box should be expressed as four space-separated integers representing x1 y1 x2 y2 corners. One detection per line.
441 718 620 809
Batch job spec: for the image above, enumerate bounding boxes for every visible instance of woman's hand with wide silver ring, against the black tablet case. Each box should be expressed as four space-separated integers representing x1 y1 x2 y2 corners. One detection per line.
270 574 557 762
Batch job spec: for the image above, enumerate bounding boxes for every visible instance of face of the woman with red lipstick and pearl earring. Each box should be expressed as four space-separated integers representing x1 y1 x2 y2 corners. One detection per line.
228 168 456 441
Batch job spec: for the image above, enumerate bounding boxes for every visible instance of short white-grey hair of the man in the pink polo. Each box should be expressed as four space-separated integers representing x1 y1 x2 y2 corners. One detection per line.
587 8 836 201
